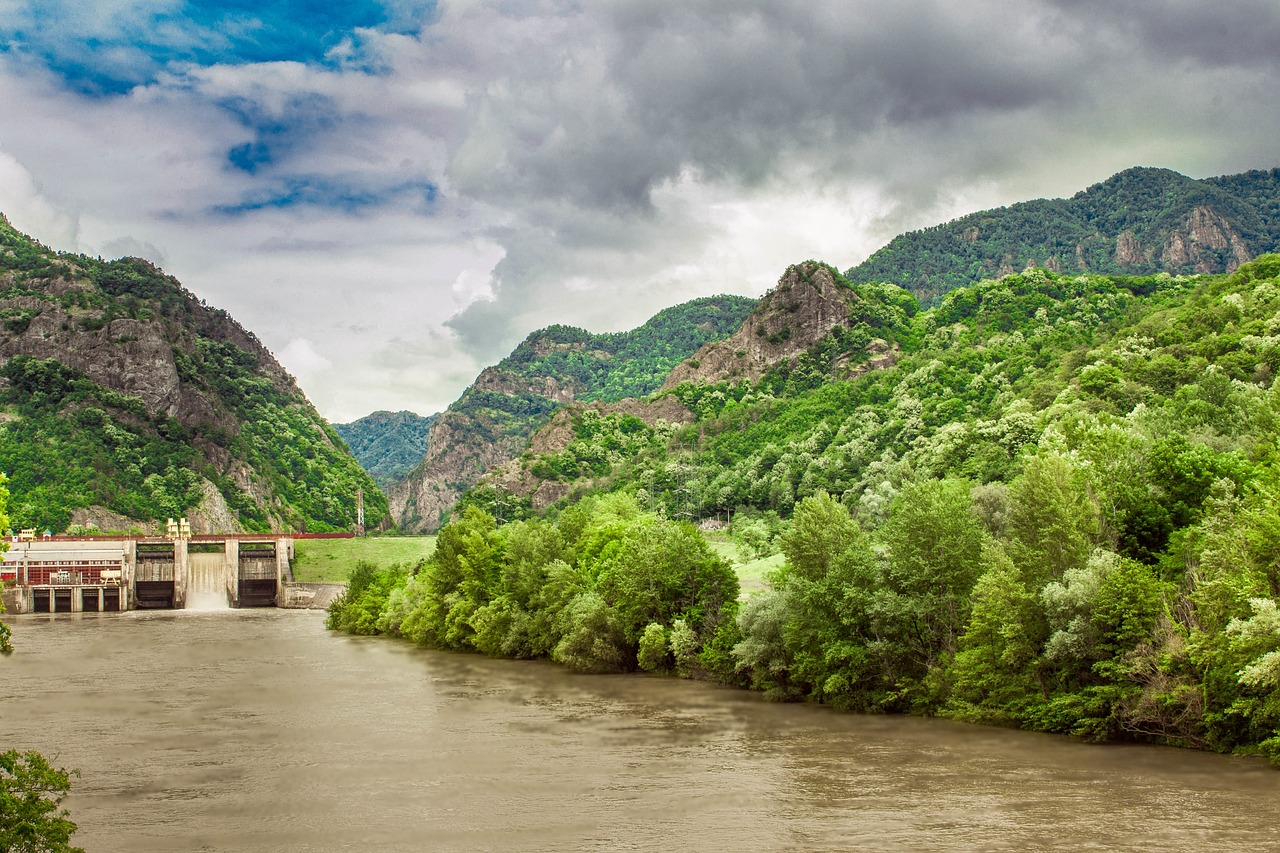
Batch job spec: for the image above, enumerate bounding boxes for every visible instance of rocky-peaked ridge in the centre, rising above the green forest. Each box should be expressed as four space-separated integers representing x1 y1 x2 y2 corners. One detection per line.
478 260 919 507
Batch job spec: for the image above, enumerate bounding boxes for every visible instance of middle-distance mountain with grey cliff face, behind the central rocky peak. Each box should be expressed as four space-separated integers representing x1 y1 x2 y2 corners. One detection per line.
389 296 755 530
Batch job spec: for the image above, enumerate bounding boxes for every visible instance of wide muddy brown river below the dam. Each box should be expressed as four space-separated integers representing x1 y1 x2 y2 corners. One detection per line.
0 610 1280 853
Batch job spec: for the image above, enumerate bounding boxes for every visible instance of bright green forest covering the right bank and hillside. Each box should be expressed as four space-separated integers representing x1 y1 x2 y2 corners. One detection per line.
329 255 1280 762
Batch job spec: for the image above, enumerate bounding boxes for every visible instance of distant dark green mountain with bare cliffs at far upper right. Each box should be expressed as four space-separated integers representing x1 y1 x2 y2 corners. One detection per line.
846 168 1280 304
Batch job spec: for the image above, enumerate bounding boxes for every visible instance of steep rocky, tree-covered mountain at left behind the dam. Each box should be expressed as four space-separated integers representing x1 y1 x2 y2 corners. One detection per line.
0 216 387 532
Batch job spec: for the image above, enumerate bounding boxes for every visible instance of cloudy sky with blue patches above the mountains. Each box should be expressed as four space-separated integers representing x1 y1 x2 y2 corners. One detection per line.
0 0 1280 423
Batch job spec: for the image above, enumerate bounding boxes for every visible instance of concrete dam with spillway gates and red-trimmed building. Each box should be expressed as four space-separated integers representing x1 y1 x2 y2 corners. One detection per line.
0 533 352 613
